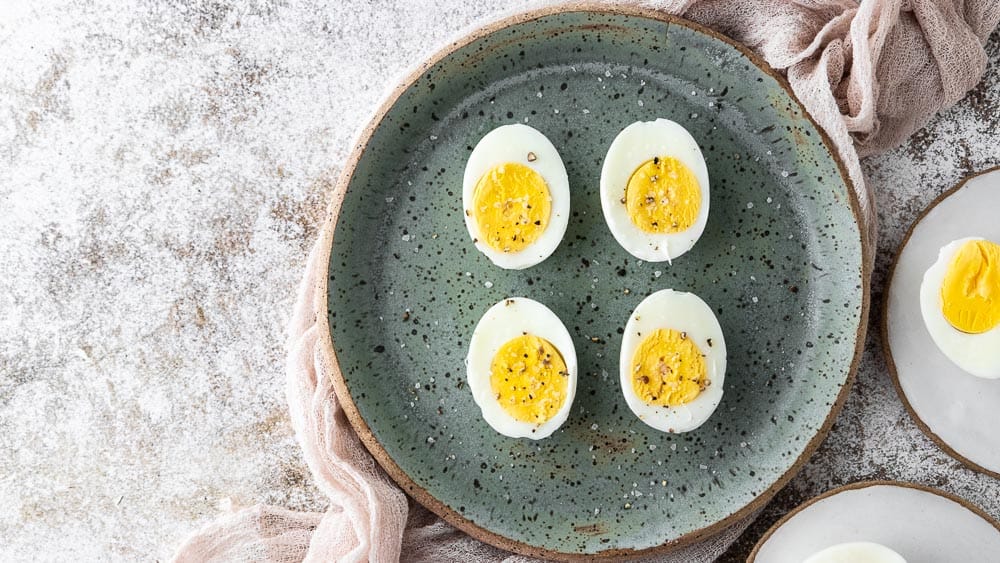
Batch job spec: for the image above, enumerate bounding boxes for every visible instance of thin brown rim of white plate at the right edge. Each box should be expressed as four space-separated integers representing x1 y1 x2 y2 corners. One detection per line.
879 166 1000 479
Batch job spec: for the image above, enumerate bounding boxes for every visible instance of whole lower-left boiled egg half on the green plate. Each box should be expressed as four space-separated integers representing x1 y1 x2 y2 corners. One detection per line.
465 297 577 440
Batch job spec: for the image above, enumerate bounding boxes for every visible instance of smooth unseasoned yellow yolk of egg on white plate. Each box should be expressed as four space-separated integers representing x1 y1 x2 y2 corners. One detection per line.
941 240 1000 334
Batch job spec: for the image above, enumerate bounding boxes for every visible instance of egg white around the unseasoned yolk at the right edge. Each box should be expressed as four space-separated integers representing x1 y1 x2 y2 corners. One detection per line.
920 237 1000 379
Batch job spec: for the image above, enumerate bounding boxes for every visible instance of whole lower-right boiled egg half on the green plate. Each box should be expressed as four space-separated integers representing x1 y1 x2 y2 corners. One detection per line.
619 289 726 433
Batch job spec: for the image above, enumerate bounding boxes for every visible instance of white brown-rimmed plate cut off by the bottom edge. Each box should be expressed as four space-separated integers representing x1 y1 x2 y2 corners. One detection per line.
747 481 1000 563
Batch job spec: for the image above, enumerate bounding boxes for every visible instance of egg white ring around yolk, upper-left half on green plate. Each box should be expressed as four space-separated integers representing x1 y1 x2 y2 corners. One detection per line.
462 123 570 270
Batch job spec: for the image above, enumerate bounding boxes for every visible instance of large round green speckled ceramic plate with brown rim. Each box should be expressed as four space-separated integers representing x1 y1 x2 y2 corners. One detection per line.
328 4 868 558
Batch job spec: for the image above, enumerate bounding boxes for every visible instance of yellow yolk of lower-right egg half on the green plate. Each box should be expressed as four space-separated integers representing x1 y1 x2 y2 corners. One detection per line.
632 328 708 407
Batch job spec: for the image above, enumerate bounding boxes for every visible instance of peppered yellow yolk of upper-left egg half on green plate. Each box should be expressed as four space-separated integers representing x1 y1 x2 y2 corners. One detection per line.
472 162 552 252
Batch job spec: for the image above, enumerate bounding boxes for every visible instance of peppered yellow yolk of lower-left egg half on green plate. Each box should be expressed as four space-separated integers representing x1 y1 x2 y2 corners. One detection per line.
490 334 569 424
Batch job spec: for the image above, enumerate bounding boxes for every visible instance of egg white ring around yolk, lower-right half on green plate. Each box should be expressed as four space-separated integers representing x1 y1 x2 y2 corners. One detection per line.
619 289 726 433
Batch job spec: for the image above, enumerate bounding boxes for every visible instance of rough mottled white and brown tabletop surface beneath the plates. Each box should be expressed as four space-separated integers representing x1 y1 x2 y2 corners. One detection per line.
0 0 1000 561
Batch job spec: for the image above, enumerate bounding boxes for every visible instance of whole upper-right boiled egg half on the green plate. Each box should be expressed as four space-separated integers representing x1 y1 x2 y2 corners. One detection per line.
601 119 709 262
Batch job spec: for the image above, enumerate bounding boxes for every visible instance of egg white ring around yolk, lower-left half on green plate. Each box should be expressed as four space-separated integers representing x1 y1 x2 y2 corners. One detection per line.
465 297 577 440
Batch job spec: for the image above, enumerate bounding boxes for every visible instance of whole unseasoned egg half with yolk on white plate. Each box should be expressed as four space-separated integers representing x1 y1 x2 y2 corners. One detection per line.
920 237 1000 379
